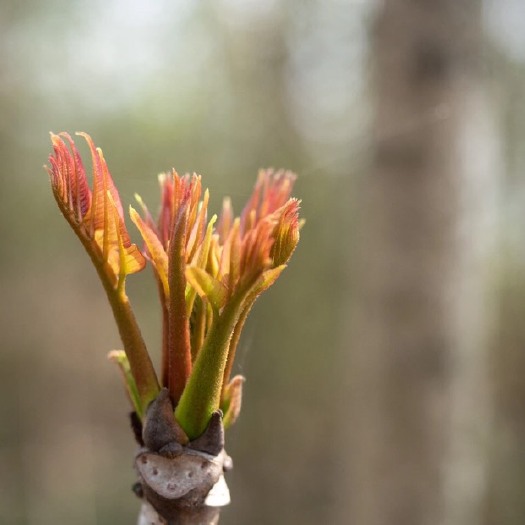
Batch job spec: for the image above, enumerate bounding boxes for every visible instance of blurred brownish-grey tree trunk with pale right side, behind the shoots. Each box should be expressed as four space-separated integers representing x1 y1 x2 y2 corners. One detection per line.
337 0 497 525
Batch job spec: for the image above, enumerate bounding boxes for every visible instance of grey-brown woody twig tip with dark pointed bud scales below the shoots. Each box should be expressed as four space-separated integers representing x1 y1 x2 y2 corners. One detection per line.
132 388 232 525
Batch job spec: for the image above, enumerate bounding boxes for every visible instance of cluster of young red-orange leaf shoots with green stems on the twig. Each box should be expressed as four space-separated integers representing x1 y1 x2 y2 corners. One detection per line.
47 133 301 439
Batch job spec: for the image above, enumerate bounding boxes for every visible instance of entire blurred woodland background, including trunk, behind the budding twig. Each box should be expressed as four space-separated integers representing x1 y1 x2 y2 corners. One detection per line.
0 0 525 525
